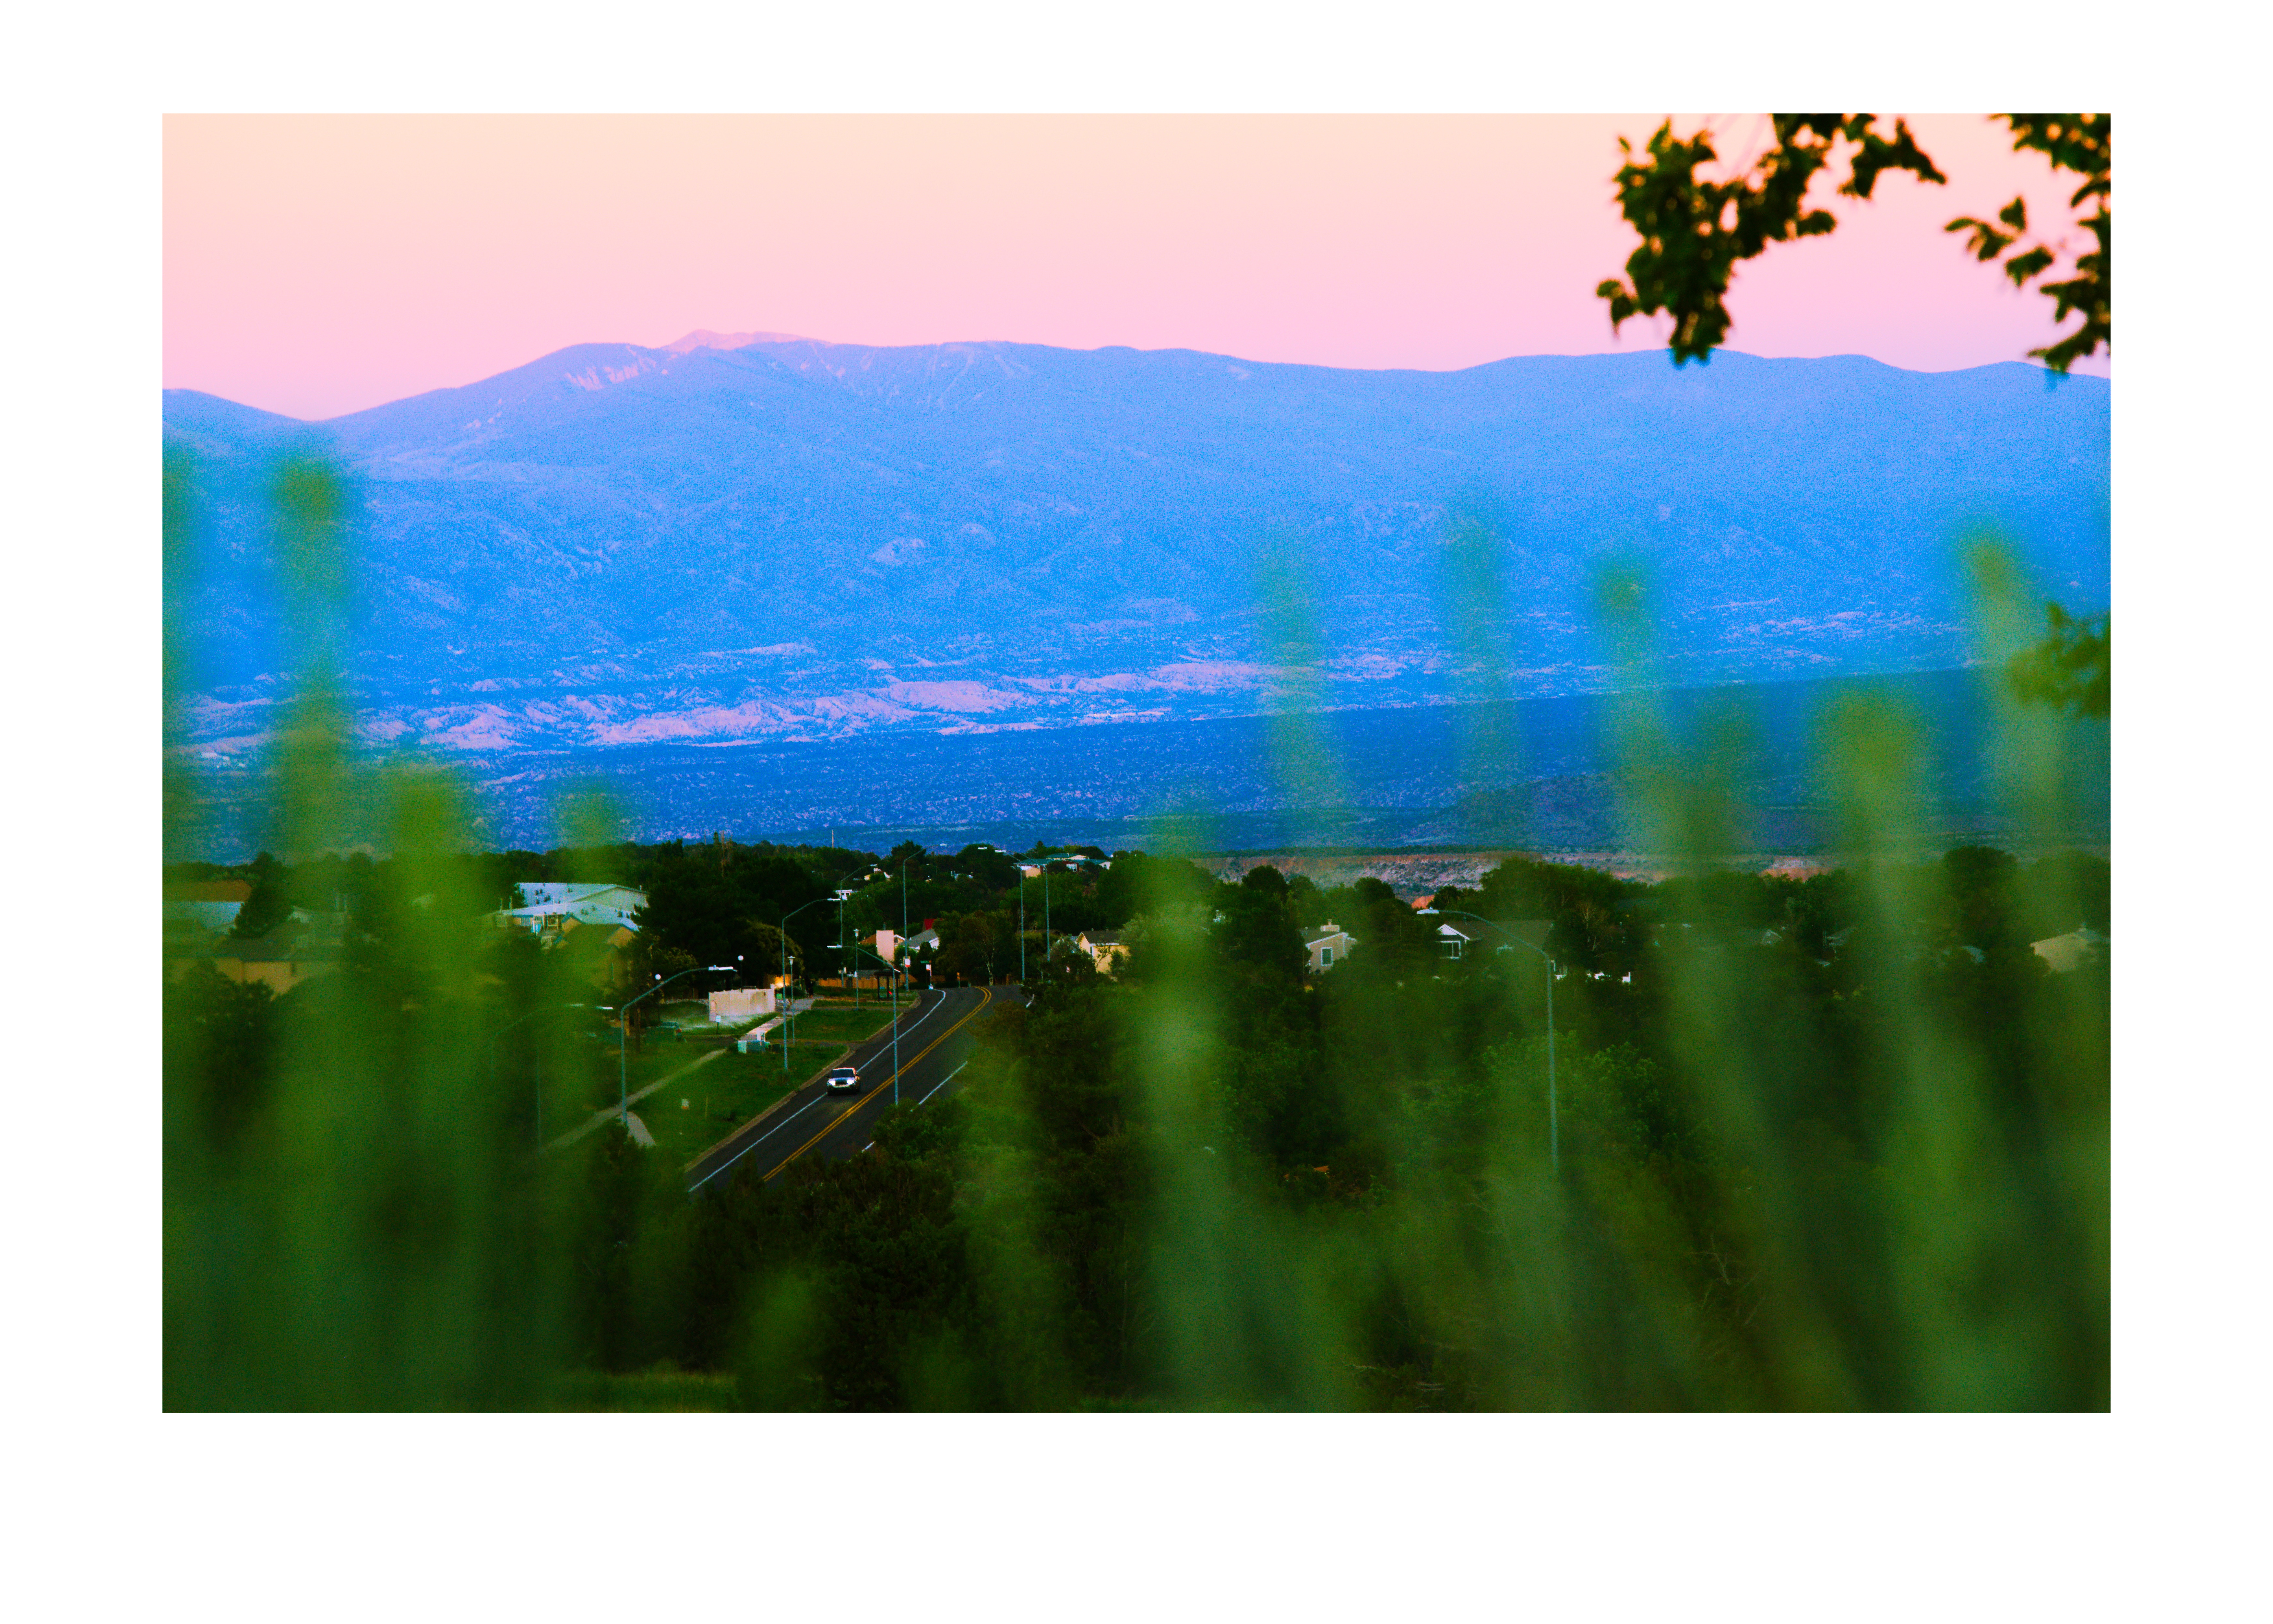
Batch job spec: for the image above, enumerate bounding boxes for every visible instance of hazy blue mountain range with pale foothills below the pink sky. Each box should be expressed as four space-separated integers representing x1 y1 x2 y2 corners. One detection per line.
166 332 2109 754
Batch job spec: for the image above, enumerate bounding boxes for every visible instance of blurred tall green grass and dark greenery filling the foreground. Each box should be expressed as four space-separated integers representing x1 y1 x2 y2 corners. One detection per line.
164 447 2109 1408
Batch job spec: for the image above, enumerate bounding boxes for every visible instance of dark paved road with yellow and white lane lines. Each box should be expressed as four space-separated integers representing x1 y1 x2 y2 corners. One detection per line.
686 986 1020 1190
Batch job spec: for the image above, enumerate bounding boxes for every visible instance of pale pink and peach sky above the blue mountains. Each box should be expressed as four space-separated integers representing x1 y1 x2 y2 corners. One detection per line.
164 113 2107 418
